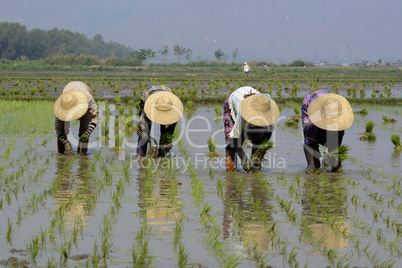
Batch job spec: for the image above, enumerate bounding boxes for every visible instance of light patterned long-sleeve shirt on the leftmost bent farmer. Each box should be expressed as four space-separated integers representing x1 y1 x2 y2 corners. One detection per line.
54 81 99 137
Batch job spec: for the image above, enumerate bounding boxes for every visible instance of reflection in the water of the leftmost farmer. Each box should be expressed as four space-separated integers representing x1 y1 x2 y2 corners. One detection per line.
54 155 94 229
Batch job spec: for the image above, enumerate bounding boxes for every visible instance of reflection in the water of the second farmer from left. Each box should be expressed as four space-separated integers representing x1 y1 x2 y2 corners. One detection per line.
137 158 181 232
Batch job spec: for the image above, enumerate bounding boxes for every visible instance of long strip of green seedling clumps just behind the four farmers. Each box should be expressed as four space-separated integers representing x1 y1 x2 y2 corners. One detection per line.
0 77 395 101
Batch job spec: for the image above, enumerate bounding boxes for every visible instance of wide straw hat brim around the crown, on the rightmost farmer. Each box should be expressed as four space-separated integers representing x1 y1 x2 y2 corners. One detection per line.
307 93 354 131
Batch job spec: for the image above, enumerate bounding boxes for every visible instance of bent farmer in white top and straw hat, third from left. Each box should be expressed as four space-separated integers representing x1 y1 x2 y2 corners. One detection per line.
223 86 279 172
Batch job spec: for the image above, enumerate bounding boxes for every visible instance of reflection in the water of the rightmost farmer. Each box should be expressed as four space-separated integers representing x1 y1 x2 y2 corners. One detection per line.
302 174 350 249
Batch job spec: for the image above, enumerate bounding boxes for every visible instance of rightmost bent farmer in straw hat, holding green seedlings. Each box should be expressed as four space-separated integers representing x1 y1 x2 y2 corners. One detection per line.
301 90 354 173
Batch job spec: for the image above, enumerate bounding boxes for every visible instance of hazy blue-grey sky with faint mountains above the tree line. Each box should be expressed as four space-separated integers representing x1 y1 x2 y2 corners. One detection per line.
0 0 402 63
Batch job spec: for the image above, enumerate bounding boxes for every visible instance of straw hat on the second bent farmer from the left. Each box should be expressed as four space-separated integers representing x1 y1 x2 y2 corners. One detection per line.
144 91 183 125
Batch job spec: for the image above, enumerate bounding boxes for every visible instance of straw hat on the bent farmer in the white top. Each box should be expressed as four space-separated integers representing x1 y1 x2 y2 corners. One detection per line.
240 94 279 127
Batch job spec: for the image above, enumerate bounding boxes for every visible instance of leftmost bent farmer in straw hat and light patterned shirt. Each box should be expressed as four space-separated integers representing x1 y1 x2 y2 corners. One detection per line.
53 81 99 155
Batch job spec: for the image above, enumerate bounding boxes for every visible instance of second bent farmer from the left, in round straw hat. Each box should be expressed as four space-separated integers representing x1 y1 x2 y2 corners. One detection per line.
137 85 183 157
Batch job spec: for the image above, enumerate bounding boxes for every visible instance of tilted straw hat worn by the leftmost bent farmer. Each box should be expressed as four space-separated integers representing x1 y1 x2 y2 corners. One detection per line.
53 90 89 121
